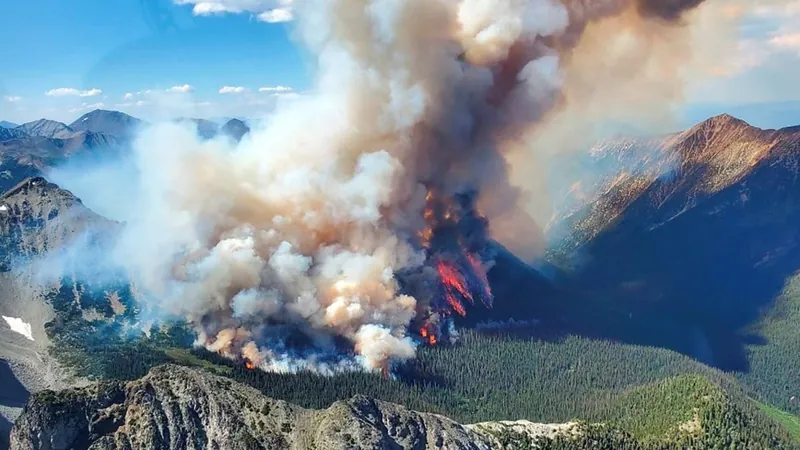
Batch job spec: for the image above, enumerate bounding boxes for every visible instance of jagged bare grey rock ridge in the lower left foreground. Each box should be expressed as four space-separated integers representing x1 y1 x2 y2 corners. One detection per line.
11 365 493 450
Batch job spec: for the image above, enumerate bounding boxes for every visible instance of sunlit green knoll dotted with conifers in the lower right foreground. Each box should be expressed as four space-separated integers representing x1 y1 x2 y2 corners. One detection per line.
492 375 795 450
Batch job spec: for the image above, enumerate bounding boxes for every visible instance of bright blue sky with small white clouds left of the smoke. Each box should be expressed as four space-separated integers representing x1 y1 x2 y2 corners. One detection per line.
0 0 309 122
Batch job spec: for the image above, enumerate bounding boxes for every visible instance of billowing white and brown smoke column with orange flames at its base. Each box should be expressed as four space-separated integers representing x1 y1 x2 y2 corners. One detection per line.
118 0 698 370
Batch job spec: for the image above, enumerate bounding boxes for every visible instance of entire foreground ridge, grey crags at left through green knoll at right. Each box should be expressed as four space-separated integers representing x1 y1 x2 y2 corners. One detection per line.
10 365 792 450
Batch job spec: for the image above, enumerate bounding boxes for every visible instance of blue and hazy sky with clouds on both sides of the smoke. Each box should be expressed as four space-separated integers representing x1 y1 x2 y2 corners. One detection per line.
0 0 800 127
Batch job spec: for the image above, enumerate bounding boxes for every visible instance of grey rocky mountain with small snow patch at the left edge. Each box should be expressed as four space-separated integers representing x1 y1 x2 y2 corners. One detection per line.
0 177 117 448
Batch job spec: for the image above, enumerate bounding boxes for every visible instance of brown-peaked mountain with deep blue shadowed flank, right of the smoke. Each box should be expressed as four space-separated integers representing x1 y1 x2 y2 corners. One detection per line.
549 115 800 412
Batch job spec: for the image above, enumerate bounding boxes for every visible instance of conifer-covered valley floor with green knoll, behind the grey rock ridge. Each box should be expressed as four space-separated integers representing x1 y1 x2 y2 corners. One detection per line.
48 316 800 448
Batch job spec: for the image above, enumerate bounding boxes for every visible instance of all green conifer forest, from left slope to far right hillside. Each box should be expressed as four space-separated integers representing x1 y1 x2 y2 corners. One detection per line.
42 266 800 450
